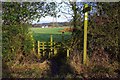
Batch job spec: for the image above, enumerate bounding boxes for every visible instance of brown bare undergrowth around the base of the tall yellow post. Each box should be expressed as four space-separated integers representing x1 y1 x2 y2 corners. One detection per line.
69 48 118 78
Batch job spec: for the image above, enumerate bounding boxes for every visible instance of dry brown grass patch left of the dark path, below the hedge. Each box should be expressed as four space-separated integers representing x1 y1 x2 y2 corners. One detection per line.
3 60 50 78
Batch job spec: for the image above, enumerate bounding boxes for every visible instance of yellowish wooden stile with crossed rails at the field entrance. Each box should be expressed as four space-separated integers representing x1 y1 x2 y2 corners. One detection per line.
33 35 70 58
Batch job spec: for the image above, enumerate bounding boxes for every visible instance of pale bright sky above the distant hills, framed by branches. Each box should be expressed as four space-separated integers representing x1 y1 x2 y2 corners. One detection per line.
33 1 72 24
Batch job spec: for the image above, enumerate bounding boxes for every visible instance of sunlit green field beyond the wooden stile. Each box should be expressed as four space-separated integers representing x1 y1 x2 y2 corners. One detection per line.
30 27 71 42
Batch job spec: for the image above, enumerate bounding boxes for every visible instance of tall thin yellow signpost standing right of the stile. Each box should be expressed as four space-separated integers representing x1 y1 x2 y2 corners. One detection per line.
83 4 88 65
